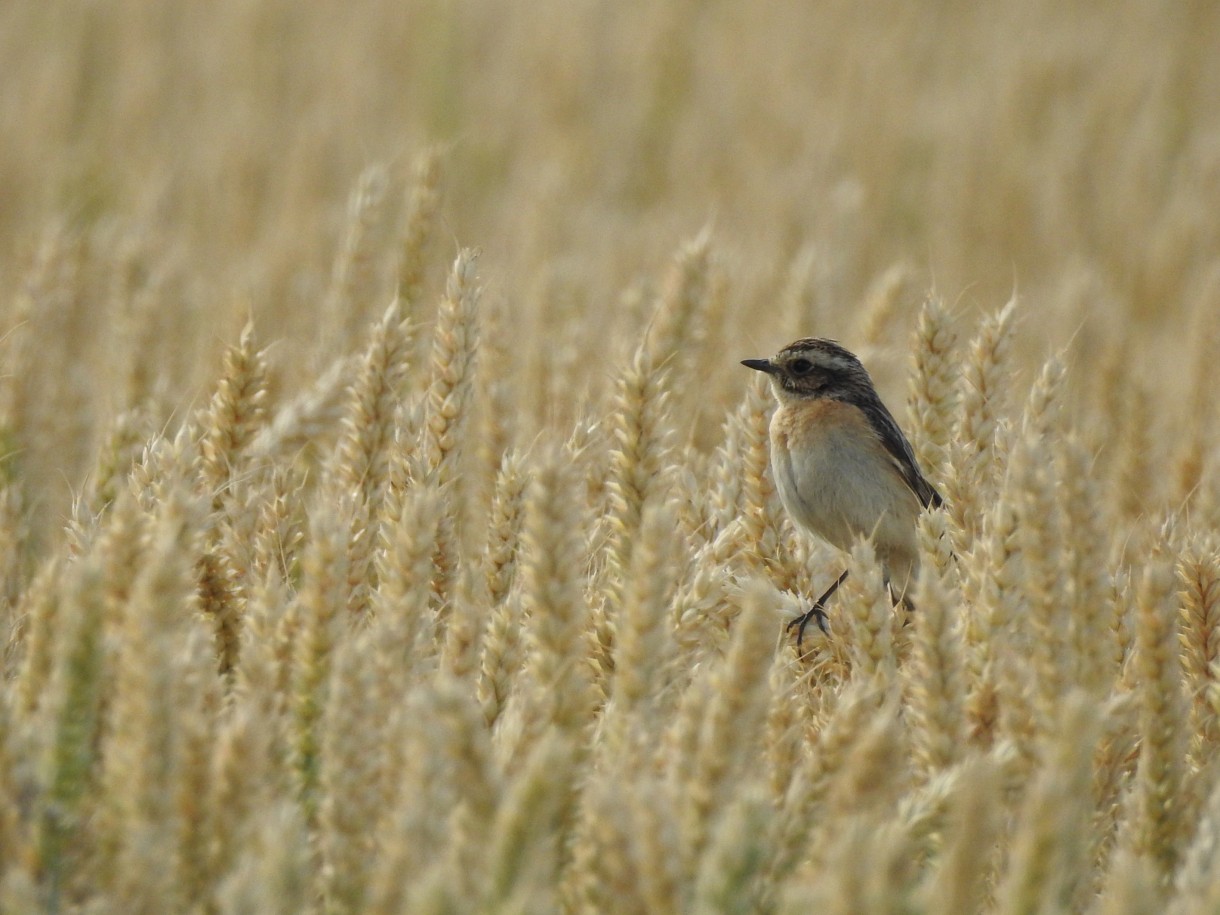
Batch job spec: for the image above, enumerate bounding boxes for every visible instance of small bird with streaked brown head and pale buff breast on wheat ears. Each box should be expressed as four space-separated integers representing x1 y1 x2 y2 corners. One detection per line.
742 337 943 650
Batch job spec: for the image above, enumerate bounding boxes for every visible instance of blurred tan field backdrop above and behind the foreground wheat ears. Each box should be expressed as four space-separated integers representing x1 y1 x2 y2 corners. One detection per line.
0 0 1220 529
